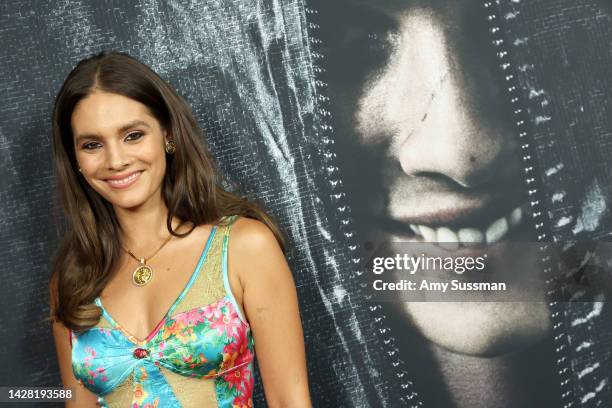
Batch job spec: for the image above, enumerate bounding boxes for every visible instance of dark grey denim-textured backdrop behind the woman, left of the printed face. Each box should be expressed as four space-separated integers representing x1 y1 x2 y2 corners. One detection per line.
0 1 412 406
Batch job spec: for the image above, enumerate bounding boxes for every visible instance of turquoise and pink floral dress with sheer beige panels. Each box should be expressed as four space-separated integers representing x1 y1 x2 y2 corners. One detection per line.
71 218 254 408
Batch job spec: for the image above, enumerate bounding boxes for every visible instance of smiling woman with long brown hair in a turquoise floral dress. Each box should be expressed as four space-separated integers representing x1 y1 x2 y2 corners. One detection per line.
50 52 310 407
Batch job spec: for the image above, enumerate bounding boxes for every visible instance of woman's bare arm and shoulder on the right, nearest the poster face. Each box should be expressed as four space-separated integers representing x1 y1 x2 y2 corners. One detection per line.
228 218 312 408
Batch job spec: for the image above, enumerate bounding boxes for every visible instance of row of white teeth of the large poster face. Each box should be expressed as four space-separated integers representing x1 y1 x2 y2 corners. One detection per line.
410 207 523 250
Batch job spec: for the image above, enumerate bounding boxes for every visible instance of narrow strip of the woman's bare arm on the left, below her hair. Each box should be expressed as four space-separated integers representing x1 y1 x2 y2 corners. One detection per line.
53 322 98 408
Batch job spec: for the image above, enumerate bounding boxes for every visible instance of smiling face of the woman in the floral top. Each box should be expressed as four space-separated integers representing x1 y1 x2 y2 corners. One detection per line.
71 91 166 210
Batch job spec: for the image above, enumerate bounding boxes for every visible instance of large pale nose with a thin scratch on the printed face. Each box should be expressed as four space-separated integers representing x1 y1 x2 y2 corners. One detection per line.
385 9 517 187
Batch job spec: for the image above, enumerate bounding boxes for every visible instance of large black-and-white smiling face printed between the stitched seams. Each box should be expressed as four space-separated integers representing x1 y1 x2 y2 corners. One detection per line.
316 0 554 407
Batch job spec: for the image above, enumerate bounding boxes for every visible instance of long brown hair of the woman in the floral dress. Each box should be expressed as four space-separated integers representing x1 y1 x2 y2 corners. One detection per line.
49 52 283 331
